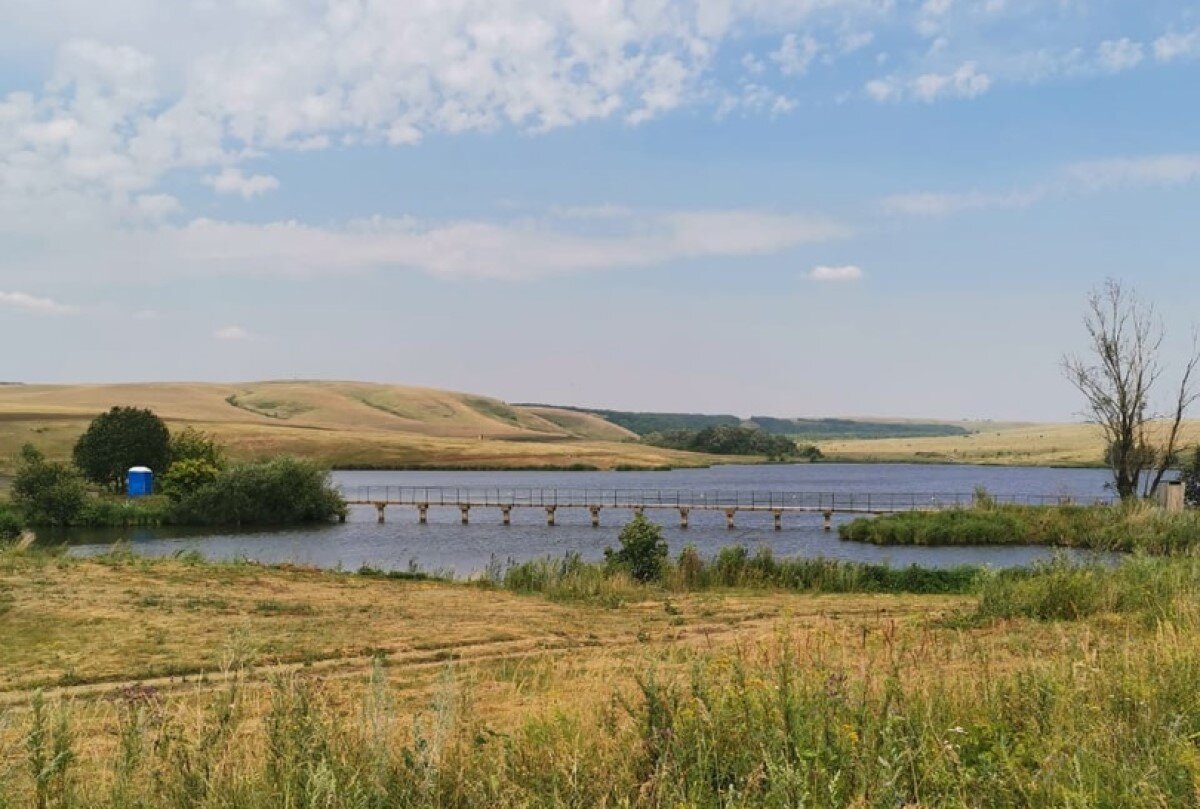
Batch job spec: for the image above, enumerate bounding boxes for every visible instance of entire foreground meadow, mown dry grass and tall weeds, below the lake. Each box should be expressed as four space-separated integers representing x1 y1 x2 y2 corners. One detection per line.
0 551 1200 808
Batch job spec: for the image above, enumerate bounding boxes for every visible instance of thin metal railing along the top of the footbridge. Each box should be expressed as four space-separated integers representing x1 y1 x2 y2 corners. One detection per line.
341 486 1109 511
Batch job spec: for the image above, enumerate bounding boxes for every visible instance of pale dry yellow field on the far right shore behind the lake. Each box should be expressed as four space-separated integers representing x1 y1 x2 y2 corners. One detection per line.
821 421 1200 466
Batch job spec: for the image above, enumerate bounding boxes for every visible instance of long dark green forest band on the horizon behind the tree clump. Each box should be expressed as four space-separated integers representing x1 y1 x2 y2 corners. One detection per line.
523 405 971 442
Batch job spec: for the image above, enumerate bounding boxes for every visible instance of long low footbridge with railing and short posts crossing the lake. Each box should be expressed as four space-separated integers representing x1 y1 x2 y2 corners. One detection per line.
342 486 1091 531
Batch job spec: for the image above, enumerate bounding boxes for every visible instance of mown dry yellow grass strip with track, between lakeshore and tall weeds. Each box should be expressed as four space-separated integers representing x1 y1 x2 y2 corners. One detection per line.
0 553 965 705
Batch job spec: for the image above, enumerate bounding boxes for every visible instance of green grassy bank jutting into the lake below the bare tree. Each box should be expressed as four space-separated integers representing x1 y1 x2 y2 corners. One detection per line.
839 503 1200 555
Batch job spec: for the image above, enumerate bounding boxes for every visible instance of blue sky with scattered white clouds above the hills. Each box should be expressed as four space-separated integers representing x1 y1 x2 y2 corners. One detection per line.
0 0 1200 420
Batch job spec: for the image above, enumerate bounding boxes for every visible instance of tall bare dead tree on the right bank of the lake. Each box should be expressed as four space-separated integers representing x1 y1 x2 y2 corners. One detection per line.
1062 280 1200 499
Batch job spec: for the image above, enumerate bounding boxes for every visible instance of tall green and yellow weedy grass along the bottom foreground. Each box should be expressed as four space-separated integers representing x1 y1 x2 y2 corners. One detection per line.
5 625 1200 809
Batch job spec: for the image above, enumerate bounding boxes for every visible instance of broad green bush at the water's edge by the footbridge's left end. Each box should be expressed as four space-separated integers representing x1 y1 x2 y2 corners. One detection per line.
172 457 346 526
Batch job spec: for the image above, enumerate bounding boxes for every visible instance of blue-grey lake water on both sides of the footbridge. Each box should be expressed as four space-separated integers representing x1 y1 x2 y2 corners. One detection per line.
68 463 1108 576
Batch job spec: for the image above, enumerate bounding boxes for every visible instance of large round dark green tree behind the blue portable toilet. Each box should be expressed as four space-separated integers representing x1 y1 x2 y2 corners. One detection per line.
74 407 170 491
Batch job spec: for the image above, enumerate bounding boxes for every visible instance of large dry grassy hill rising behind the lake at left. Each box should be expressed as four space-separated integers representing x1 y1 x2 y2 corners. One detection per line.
0 382 712 469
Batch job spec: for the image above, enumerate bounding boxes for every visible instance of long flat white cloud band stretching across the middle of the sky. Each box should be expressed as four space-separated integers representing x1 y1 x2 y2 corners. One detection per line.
6 206 851 281
